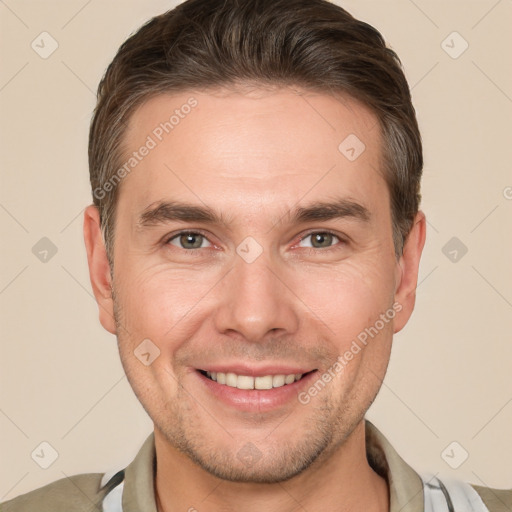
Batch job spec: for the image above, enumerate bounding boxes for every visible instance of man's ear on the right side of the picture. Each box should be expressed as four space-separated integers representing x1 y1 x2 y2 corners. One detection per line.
394 211 427 333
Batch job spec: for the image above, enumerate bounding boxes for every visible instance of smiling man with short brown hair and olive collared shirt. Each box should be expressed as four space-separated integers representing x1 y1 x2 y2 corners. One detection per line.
2 0 512 512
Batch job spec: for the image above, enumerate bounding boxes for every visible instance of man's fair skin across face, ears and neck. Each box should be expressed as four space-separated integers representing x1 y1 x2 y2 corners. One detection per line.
84 89 425 512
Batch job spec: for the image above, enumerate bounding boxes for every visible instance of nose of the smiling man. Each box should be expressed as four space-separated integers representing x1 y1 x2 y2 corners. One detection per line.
214 252 300 343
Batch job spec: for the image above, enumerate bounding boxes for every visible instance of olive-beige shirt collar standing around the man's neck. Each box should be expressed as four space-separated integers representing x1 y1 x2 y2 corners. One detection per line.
107 420 424 512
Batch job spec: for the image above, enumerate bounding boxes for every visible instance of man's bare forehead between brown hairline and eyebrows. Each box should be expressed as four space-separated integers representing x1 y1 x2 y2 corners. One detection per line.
119 89 389 220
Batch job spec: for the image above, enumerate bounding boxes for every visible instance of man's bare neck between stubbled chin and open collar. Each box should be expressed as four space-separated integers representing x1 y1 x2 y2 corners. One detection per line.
155 421 389 512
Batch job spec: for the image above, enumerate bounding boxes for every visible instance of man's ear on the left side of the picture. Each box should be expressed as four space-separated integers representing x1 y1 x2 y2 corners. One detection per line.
84 205 116 334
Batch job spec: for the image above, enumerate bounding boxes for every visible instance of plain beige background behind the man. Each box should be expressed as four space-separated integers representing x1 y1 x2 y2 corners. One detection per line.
0 0 512 501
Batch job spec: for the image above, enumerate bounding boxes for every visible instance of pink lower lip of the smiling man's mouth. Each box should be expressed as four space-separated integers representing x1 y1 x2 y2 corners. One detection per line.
195 370 317 412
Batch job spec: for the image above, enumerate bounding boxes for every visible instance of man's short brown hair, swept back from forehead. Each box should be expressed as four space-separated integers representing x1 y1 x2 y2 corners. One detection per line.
89 0 423 263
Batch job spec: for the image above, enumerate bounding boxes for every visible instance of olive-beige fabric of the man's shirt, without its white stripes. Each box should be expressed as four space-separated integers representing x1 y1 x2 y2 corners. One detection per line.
0 420 512 512
